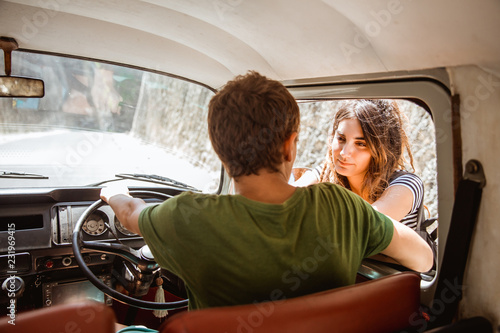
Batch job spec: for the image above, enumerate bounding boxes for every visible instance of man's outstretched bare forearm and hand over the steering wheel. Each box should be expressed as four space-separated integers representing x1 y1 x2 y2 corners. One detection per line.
101 187 147 235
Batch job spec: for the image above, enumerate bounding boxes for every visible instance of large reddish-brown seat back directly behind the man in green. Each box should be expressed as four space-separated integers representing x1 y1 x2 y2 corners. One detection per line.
161 272 420 333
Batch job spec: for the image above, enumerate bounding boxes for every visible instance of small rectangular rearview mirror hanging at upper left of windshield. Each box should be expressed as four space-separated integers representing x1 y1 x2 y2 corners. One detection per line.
0 76 45 98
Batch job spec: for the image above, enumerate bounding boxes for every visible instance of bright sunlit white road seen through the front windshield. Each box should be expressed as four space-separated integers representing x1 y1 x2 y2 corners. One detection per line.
0 130 218 189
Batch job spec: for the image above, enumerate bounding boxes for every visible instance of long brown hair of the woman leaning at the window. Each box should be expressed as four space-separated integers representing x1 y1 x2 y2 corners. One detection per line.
320 99 414 203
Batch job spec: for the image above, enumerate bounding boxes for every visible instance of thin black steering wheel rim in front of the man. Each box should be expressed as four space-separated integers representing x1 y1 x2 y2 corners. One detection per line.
71 191 189 310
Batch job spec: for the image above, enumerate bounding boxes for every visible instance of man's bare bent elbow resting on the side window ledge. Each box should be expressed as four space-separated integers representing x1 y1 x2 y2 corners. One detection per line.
382 215 434 272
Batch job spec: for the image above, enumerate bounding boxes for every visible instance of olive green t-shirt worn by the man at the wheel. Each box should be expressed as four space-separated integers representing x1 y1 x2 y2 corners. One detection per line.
139 183 394 309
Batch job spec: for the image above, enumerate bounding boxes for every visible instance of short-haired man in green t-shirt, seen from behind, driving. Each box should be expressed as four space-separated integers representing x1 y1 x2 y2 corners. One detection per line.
101 72 433 309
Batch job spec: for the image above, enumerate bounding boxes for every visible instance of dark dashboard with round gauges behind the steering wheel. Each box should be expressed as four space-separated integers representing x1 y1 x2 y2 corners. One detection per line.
0 187 178 315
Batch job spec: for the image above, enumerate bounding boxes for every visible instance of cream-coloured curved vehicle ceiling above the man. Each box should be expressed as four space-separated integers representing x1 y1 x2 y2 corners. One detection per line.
0 0 500 88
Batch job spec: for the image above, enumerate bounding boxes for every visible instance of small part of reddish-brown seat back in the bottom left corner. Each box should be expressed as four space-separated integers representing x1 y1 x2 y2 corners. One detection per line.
0 301 116 333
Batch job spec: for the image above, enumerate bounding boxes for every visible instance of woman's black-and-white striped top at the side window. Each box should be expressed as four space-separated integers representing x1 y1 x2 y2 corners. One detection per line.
387 171 424 229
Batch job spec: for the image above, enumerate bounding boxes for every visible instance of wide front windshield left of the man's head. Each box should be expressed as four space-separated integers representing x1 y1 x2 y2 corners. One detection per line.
0 52 221 192
